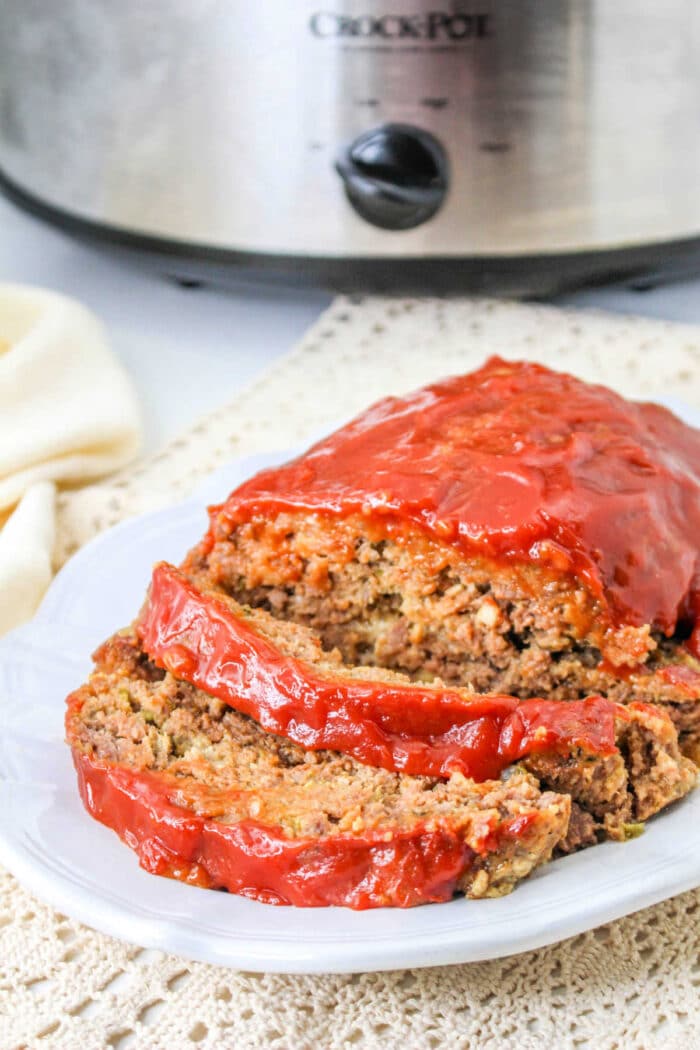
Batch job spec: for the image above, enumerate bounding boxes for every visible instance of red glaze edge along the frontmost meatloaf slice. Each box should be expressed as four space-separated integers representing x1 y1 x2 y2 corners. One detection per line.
73 749 484 910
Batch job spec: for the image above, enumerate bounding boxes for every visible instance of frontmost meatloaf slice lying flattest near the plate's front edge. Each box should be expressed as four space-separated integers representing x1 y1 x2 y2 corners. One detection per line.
66 633 570 908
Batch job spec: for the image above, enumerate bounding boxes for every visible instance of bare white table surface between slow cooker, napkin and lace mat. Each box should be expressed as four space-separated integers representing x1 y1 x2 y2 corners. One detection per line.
0 197 700 450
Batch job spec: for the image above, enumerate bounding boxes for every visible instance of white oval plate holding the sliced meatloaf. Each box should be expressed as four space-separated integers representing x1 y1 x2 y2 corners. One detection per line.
0 428 700 973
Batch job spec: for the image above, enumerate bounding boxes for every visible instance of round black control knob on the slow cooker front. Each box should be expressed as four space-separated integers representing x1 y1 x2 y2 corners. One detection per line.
336 124 447 230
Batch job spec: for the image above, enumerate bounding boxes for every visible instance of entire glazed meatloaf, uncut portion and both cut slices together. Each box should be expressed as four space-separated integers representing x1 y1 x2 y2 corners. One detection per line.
66 358 700 908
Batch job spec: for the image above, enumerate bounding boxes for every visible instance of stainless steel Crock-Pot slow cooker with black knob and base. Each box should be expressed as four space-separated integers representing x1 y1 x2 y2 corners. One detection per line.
0 0 700 293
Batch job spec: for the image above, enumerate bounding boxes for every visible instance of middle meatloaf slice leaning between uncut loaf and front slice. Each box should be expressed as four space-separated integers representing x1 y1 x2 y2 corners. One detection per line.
136 564 696 838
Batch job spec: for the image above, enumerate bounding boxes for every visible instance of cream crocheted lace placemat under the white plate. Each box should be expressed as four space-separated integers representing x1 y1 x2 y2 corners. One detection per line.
0 298 700 1050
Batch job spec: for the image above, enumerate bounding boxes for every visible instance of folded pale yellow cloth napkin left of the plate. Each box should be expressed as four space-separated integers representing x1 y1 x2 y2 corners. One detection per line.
0 284 141 634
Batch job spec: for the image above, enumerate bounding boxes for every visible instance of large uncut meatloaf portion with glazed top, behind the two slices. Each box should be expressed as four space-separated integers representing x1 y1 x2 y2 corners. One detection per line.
185 358 700 755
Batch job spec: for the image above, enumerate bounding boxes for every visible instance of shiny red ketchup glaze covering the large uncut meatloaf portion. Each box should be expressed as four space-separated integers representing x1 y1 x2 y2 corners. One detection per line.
210 357 700 654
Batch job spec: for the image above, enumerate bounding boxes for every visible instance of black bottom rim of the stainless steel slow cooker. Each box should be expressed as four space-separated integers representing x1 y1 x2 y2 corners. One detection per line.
0 171 700 298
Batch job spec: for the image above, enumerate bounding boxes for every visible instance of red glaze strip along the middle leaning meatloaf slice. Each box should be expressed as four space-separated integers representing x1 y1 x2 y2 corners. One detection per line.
136 564 624 780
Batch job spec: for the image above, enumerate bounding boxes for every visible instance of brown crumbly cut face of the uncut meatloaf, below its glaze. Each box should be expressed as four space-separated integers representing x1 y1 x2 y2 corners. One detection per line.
185 511 700 757
